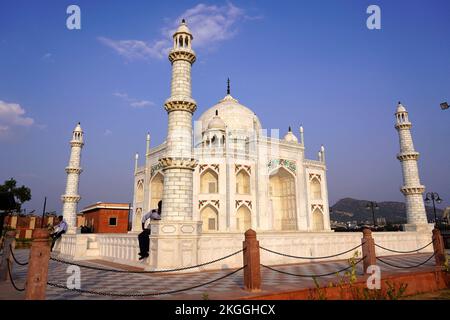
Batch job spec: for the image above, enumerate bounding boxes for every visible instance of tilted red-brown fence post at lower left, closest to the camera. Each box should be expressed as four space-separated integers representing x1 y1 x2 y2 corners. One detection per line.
25 229 50 300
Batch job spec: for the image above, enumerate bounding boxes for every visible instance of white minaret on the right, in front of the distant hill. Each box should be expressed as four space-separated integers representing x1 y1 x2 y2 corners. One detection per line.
395 102 428 231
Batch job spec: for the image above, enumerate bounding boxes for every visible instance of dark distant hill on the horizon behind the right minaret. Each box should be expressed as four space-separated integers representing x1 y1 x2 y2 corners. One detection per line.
330 198 443 223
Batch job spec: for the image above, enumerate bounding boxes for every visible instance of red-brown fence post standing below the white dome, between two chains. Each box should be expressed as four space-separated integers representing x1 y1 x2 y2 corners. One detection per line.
243 229 261 291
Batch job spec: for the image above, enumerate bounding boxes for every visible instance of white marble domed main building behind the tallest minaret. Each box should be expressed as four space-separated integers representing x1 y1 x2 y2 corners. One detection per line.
132 87 330 233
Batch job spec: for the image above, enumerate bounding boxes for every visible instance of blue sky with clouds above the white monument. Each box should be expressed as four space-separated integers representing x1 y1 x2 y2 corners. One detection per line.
0 0 450 212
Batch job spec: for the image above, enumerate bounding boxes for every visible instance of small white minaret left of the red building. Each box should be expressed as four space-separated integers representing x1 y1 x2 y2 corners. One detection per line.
61 122 84 233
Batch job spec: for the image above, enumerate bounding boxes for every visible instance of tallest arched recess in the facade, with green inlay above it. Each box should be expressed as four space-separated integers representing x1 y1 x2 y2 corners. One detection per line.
269 167 297 230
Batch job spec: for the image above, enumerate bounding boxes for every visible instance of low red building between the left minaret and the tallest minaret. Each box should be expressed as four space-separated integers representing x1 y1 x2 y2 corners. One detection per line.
84 209 128 233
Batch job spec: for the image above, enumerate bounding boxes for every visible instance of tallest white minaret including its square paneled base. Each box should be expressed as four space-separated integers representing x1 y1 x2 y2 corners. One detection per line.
149 20 201 269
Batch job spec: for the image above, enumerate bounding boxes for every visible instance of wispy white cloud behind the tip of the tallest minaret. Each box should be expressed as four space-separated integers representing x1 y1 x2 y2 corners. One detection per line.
98 3 250 61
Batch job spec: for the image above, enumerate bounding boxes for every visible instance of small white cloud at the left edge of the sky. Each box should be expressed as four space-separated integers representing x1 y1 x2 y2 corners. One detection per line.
0 100 34 135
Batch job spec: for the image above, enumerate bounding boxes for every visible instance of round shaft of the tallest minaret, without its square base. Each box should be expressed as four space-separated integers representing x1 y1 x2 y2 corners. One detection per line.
160 19 197 221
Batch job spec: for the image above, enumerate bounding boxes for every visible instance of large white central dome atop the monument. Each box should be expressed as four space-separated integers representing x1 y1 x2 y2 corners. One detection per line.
198 94 261 132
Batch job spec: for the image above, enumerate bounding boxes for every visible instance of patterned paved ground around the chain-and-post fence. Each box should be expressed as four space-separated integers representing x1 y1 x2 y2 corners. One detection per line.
0 250 442 300
